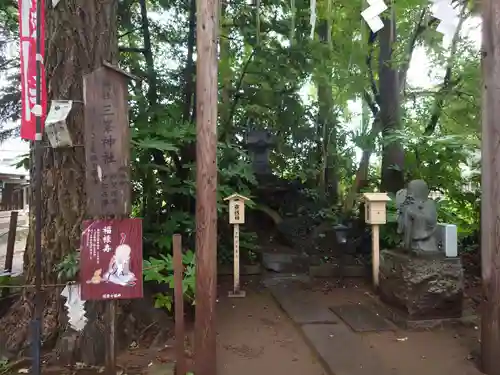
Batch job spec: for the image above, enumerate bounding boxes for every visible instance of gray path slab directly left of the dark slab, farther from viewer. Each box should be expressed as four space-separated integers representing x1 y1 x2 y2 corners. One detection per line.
268 284 339 324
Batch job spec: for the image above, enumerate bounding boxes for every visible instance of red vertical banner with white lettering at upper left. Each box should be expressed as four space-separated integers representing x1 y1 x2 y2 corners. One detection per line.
19 0 47 141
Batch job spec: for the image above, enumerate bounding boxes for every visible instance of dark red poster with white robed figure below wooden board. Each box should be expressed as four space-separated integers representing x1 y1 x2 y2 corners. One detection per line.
80 219 143 301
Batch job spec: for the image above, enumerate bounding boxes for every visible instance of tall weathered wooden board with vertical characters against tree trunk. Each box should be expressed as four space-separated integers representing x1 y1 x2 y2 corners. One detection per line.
83 64 131 217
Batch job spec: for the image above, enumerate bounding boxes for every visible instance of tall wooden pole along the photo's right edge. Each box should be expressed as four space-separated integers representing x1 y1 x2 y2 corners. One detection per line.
481 0 500 375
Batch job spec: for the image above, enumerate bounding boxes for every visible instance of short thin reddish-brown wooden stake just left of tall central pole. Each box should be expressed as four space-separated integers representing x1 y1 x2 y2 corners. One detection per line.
173 234 186 375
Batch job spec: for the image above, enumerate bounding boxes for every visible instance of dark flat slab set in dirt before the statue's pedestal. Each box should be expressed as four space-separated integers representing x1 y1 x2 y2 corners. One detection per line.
331 304 395 332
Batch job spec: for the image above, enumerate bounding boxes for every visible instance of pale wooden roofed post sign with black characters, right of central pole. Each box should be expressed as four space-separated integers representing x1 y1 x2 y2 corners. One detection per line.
224 194 249 297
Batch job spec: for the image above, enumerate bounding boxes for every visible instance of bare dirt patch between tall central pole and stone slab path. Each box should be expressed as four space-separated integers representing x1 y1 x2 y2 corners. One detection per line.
217 281 327 375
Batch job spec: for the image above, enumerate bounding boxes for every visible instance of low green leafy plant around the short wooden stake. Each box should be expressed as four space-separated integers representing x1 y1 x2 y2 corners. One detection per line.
143 248 196 311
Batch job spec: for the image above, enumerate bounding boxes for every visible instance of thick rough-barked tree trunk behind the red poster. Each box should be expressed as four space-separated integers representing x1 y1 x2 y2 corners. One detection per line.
0 0 118 363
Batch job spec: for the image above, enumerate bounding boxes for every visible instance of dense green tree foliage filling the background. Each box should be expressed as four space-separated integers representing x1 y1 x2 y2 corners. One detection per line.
0 0 481 278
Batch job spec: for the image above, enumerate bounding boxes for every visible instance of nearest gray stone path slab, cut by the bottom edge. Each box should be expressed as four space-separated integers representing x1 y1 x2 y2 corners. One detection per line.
300 323 396 375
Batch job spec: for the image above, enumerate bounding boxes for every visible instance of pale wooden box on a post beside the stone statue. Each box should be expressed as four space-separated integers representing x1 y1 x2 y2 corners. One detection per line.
363 193 391 289
